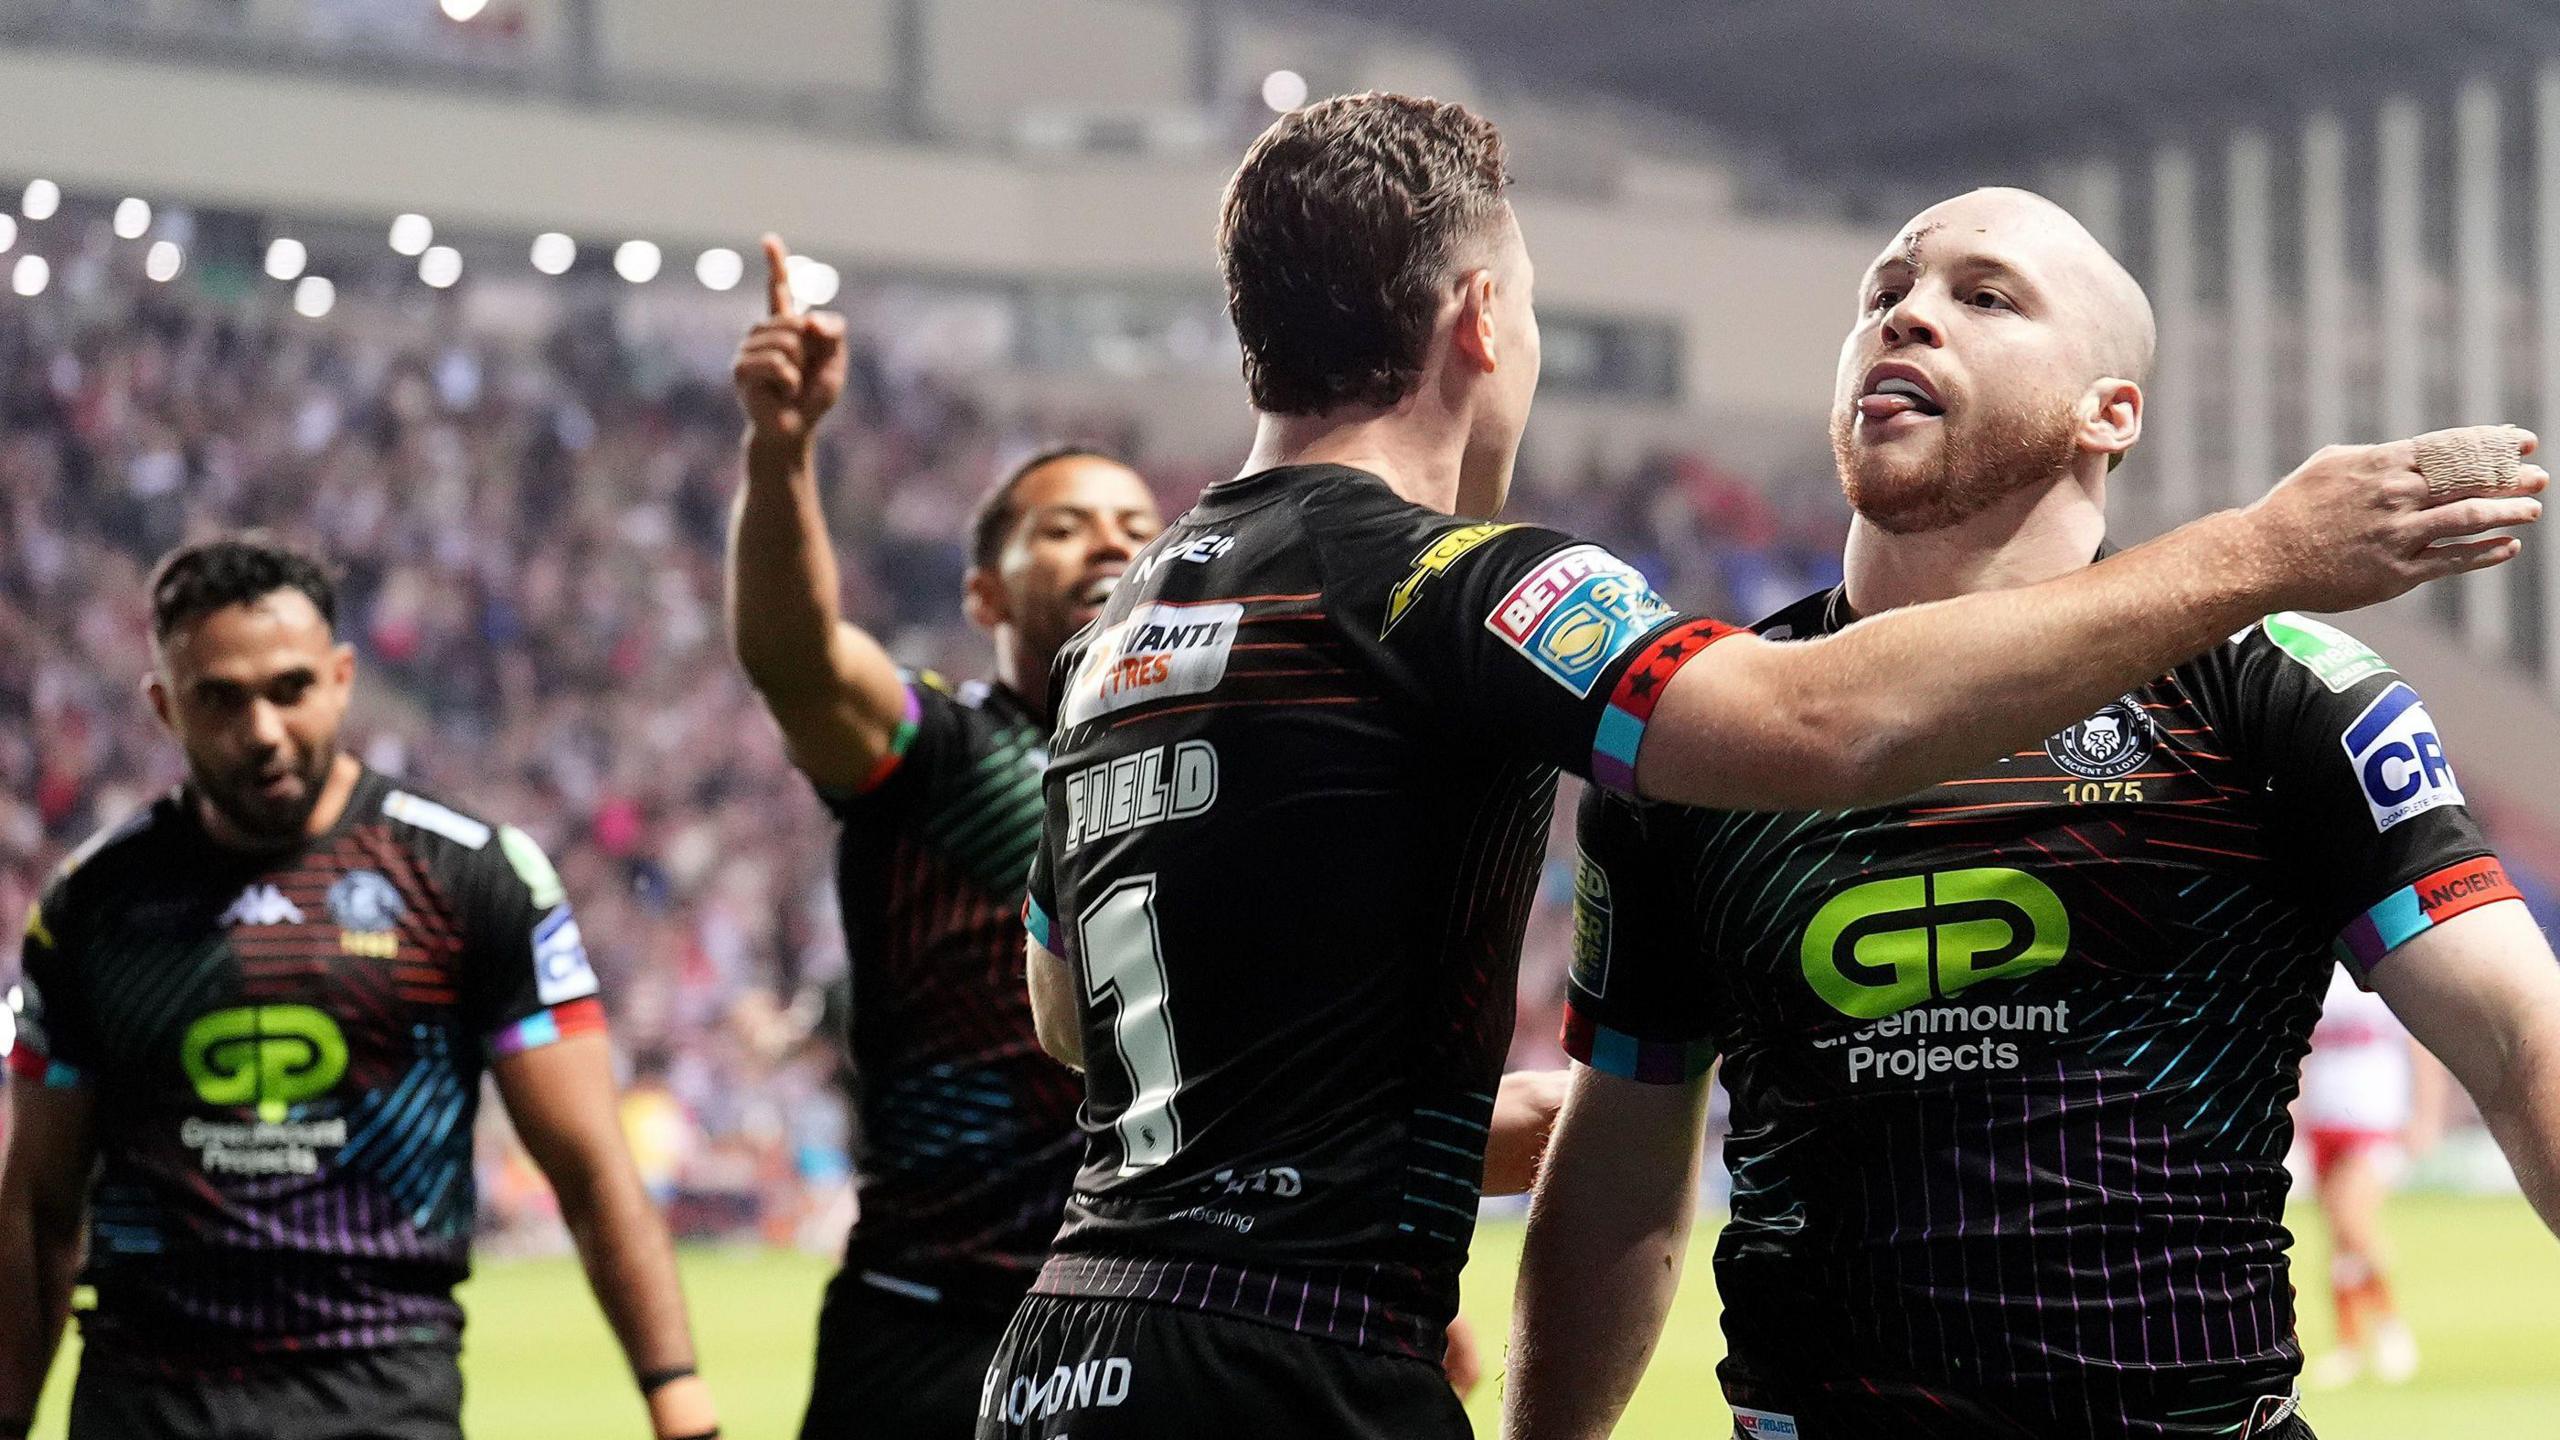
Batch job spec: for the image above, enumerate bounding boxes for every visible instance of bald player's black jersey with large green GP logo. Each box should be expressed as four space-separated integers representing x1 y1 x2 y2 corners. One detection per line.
1567 592 2514 1437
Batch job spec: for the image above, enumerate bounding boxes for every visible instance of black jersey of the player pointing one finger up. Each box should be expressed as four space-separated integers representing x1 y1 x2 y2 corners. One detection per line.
819 671 1083 1314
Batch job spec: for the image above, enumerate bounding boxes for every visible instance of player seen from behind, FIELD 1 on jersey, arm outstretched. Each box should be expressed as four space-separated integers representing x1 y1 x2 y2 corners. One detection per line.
978 95 2540 1440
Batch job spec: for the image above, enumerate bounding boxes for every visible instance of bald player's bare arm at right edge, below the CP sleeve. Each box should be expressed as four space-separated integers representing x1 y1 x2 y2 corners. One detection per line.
2373 899 2560 1235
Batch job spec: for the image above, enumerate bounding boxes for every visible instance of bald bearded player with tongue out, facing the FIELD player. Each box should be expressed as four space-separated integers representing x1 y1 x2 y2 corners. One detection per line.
1505 190 2560 1440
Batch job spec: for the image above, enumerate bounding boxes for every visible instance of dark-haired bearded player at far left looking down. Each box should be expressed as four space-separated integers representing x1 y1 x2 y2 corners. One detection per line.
0 541 717 1440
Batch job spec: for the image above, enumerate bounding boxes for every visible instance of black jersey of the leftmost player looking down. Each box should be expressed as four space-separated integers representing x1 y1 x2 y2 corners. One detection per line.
10 771 604 1368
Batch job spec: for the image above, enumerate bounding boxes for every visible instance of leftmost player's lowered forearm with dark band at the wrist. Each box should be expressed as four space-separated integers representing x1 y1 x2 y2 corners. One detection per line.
494 1033 719 1440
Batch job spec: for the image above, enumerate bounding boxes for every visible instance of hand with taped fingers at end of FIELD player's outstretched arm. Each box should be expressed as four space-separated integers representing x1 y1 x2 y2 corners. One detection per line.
2243 425 2550 610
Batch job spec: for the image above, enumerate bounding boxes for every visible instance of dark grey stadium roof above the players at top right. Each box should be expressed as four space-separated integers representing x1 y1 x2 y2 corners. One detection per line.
1303 0 2529 196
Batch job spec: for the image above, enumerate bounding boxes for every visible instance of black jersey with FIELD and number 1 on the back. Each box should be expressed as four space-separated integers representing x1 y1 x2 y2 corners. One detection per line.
1029 466 1731 1355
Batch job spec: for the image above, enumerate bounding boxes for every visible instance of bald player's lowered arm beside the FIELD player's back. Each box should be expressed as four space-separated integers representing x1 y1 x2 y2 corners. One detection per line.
1503 1066 1708 1440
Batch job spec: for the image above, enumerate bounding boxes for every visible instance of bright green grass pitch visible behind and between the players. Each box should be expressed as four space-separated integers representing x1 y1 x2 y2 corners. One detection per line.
36 1197 2560 1440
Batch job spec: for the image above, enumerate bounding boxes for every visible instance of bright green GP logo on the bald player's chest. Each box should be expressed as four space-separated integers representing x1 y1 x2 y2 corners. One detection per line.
1802 866 2071 1020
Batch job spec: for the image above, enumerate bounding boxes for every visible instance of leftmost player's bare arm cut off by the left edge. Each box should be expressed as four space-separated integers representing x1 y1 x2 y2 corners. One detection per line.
0 1081 92 1435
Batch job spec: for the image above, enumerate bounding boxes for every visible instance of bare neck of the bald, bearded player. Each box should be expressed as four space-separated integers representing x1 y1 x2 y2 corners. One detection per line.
1841 474 2107 615
